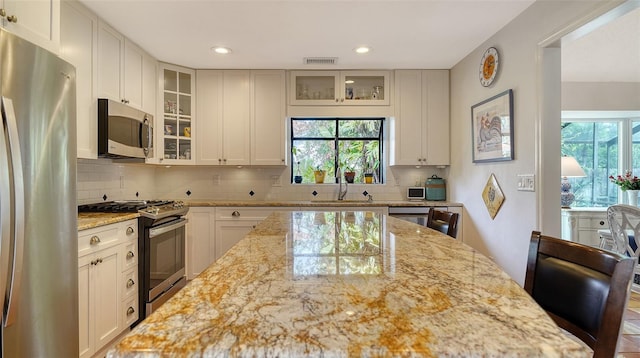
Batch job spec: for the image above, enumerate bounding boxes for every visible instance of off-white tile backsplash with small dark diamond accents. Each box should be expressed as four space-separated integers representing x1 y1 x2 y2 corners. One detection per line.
77 159 446 204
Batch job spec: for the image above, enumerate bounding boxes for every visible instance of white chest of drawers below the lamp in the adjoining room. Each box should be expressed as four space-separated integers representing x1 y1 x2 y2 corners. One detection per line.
561 207 609 247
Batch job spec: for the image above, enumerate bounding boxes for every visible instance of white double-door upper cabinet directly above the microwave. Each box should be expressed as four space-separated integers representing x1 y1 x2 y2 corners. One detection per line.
98 21 157 114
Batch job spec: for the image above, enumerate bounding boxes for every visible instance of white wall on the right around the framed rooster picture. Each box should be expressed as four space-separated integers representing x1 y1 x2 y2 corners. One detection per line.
449 1 624 283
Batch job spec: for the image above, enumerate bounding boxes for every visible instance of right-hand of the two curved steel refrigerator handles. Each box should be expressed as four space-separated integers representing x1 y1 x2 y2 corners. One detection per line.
2 96 25 327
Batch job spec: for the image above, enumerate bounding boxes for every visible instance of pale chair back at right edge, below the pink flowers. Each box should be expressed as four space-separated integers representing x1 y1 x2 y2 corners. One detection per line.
607 204 640 257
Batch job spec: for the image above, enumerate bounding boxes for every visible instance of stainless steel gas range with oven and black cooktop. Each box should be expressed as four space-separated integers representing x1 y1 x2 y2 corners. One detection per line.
78 200 189 326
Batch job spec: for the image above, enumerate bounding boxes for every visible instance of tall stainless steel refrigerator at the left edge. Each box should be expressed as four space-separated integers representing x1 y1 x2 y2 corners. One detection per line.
0 29 78 358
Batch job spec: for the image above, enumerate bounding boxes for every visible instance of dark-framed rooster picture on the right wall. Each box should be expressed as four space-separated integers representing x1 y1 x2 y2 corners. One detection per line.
471 89 514 163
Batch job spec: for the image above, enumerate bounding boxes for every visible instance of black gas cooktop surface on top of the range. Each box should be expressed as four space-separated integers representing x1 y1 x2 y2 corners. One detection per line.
78 200 189 219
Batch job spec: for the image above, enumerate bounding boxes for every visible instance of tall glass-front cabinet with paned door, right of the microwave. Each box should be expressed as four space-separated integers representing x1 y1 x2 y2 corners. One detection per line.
156 64 195 164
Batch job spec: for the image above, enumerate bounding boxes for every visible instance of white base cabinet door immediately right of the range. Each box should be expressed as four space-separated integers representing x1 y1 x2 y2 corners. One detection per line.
186 206 216 280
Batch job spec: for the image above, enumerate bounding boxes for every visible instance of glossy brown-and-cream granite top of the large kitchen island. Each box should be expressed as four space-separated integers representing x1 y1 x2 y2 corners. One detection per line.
107 211 590 358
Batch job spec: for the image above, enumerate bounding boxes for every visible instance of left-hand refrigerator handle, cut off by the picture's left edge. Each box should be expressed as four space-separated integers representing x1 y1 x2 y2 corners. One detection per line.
0 96 13 326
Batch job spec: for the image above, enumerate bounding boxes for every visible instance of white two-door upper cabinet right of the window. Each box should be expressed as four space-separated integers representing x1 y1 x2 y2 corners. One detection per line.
390 70 450 166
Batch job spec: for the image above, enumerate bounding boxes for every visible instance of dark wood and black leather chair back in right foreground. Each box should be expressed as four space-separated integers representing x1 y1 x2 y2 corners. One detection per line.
524 231 635 357
